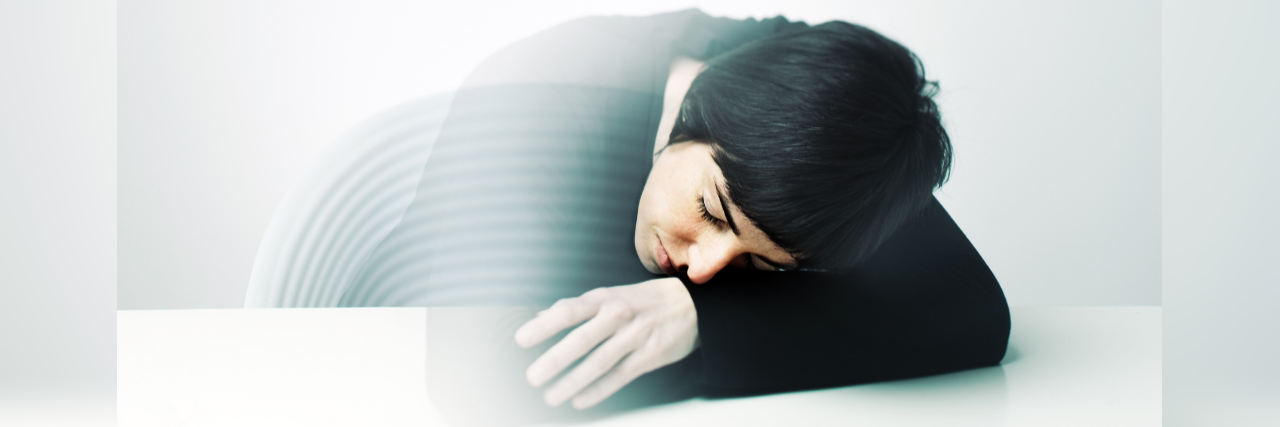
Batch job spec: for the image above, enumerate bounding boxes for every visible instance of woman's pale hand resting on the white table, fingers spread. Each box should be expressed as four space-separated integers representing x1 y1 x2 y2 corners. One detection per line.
516 277 698 409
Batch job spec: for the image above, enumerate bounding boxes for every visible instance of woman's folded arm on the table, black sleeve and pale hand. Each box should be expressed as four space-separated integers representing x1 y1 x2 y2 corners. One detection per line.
516 199 1010 408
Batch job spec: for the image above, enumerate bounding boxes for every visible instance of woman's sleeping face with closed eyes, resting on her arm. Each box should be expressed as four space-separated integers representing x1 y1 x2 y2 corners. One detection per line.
636 142 796 284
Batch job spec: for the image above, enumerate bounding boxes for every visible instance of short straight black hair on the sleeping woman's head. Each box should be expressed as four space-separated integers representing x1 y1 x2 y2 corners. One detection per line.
671 22 951 270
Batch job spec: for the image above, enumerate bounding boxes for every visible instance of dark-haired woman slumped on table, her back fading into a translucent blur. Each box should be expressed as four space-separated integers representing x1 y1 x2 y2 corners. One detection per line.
247 10 1010 423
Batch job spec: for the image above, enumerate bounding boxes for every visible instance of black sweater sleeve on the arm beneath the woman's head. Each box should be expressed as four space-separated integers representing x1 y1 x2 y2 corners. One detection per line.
686 199 1010 395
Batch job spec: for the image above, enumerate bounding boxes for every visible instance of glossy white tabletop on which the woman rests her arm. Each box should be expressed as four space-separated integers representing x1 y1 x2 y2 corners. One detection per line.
116 307 1161 426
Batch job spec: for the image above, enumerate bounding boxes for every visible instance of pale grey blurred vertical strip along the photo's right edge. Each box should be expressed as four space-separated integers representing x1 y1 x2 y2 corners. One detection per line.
1162 0 1280 419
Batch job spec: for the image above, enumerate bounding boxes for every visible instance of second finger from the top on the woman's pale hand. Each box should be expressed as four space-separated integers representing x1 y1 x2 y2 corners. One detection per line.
525 308 631 387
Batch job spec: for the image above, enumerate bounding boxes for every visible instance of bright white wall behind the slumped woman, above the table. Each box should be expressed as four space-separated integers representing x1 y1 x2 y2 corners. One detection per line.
118 0 1162 309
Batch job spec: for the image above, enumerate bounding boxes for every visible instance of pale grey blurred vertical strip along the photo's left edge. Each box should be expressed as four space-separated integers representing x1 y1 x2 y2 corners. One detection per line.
0 0 116 414
